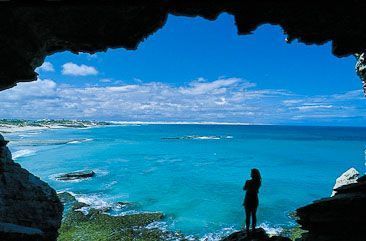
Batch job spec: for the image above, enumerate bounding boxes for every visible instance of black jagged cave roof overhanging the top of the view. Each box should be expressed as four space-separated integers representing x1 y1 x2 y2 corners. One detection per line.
0 0 366 90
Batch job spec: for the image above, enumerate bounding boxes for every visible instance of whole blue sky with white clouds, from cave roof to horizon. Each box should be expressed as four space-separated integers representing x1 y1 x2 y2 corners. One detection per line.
0 14 366 126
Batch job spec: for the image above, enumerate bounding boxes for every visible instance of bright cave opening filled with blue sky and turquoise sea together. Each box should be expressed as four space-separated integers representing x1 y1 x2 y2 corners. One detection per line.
0 11 366 240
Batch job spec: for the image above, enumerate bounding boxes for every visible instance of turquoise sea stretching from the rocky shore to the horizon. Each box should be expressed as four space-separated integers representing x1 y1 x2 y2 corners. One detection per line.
5 125 366 237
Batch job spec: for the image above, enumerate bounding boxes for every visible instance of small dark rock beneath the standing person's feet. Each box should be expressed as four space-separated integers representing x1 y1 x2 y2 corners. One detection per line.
221 228 291 241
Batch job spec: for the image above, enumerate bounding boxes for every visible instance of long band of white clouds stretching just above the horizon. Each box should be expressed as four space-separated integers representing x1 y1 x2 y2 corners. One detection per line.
0 78 366 124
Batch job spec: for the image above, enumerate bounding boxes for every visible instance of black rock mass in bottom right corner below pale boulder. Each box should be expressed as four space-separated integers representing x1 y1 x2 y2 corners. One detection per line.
297 169 366 241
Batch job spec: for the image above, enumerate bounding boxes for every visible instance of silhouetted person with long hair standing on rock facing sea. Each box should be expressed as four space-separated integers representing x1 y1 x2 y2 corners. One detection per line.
243 168 262 234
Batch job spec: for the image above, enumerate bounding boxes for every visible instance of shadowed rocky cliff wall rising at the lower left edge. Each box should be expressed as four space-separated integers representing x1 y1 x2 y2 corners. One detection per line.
0 135 63 241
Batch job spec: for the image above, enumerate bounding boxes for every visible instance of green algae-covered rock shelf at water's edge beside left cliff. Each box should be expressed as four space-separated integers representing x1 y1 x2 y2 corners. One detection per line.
58 199 186 241
